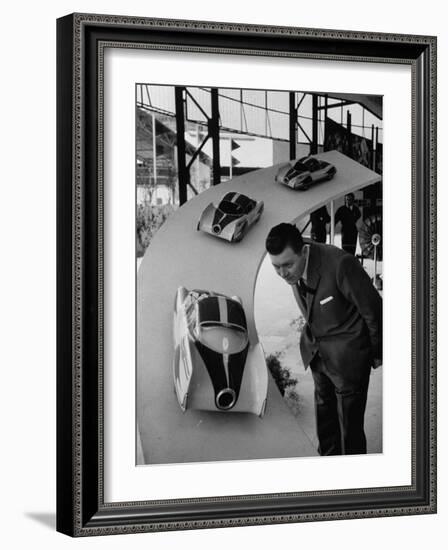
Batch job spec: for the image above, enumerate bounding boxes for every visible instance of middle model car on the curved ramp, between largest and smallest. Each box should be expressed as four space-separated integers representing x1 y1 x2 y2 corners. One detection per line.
197 192 264 242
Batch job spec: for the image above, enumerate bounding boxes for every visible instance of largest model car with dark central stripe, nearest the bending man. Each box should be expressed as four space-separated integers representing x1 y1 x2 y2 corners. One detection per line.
173 287 268 417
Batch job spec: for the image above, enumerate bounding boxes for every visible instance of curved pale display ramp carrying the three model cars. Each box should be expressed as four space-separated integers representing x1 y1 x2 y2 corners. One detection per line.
136 151 381 464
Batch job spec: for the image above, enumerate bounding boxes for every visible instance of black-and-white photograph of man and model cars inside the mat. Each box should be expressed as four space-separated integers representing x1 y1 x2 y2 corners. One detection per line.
135 82 382 465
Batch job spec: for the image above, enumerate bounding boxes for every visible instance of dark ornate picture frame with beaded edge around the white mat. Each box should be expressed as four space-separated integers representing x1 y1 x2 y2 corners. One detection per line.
57 14 436 536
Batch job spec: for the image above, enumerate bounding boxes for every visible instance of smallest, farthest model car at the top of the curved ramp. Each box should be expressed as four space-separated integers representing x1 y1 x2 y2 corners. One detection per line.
275 156 336 191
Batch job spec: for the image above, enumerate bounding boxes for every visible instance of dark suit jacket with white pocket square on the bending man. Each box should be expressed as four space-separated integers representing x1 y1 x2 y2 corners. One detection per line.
293 243 382 381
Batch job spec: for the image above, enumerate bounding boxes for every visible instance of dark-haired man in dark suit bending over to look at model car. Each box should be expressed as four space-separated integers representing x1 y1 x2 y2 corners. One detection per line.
266 223 382 455
